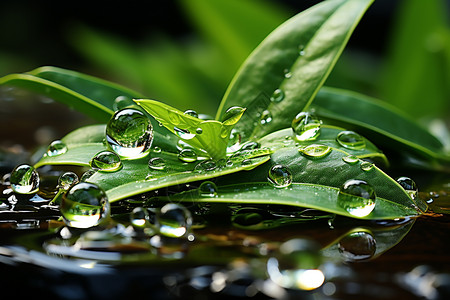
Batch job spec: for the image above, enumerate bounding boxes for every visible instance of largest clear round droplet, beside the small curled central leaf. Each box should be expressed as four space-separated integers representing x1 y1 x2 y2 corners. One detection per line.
106 108 153 159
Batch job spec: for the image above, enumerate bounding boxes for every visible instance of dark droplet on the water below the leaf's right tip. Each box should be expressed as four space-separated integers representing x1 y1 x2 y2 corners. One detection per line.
338 231 377 261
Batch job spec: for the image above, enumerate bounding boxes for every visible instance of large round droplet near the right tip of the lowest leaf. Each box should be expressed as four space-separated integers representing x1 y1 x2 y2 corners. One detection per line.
338 179 376 218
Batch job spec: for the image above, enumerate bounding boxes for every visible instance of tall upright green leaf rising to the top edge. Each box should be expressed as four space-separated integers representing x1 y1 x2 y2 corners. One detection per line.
216 0 372 140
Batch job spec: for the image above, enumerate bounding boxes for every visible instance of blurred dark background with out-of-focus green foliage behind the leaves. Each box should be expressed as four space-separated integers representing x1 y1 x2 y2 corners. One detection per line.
0 0 450 122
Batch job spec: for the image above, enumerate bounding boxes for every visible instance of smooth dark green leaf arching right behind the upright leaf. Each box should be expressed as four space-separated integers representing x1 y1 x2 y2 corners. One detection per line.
312 87 450 168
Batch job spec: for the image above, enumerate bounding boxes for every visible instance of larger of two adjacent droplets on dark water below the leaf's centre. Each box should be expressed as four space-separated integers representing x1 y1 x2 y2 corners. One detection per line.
158 203 192 238
